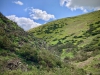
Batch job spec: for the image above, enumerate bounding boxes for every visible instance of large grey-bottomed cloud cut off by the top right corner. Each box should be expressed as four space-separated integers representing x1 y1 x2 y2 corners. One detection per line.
60 0 100 12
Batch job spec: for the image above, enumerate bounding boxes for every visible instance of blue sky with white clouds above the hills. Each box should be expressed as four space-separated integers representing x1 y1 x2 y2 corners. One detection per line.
0 0 100 31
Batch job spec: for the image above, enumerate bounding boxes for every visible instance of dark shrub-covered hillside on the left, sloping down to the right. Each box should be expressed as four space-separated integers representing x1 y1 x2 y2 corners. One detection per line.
0 13 86 75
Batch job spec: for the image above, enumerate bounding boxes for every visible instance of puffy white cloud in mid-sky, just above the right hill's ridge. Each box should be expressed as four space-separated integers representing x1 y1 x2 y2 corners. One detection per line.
29 8 55 21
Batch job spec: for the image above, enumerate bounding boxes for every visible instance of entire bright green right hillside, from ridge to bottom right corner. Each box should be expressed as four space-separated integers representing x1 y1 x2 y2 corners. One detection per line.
28 11 100 75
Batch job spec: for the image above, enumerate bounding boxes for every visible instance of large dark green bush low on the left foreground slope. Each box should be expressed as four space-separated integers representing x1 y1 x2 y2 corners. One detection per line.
18 45 61 68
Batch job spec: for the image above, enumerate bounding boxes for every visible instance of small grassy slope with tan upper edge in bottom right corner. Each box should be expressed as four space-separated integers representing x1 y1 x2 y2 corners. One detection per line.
74 54 100 75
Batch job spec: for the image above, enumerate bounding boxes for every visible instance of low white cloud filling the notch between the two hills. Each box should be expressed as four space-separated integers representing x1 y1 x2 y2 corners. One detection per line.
6 15 41 30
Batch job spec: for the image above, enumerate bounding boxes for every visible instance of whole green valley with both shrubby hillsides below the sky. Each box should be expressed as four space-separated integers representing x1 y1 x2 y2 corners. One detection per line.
0 10 100 75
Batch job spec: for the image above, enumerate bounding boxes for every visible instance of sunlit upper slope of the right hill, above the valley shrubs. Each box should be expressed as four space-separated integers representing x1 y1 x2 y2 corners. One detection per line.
29 11 100 47
